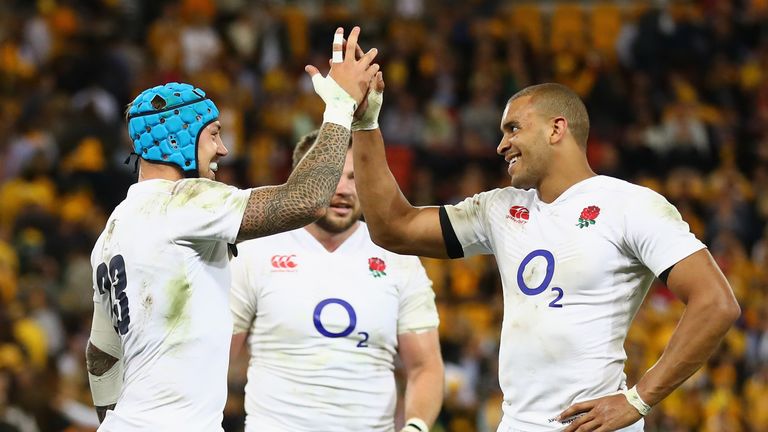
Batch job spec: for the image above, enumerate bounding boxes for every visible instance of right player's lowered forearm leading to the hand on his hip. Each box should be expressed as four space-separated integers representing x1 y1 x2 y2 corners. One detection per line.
637 299 738 406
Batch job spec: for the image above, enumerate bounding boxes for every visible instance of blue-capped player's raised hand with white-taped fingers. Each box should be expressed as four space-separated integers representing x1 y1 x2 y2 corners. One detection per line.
304 26 379 105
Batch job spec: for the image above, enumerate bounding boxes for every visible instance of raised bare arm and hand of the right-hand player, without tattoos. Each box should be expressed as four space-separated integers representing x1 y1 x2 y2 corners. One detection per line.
352 73 448 258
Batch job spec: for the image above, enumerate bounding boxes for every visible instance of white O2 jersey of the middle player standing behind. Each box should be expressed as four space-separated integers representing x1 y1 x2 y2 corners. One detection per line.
231 222 438 432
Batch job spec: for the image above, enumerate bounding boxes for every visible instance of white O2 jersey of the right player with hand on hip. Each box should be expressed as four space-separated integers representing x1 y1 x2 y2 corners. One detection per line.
445 176 704 432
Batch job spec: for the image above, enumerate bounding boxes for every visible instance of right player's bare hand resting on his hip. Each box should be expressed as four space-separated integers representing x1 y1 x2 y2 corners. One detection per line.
558 394 642 432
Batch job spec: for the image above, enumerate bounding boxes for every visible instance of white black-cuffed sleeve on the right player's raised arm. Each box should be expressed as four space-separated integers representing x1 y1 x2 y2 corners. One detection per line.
443 191 493 257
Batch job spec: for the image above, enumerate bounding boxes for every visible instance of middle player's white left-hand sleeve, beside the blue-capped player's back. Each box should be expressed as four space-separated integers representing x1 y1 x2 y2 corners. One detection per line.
229 253 258 334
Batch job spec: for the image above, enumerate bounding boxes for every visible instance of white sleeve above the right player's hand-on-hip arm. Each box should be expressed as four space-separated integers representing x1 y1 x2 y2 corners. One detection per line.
624 190 706 276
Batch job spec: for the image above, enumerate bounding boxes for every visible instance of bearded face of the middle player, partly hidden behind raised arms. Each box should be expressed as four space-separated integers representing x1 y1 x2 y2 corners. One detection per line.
315 150 363 234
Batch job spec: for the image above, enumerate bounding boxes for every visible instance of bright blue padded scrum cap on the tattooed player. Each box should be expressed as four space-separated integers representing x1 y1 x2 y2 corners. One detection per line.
128 83 219 177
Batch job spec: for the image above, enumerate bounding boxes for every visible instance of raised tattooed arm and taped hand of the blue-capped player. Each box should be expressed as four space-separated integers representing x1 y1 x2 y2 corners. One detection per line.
238 27 379 241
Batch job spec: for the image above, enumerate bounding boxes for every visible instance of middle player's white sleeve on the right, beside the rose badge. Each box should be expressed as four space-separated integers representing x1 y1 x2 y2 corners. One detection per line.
397 256 440 334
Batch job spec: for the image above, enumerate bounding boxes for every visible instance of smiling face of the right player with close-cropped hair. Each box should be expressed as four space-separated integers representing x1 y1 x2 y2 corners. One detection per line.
496 96 552 189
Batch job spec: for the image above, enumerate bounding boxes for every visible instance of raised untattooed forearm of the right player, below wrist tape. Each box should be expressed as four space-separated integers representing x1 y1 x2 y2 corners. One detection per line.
352 129 414 243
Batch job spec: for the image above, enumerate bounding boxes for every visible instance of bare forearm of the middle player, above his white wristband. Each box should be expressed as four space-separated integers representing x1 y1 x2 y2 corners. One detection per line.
405 364 444 426
